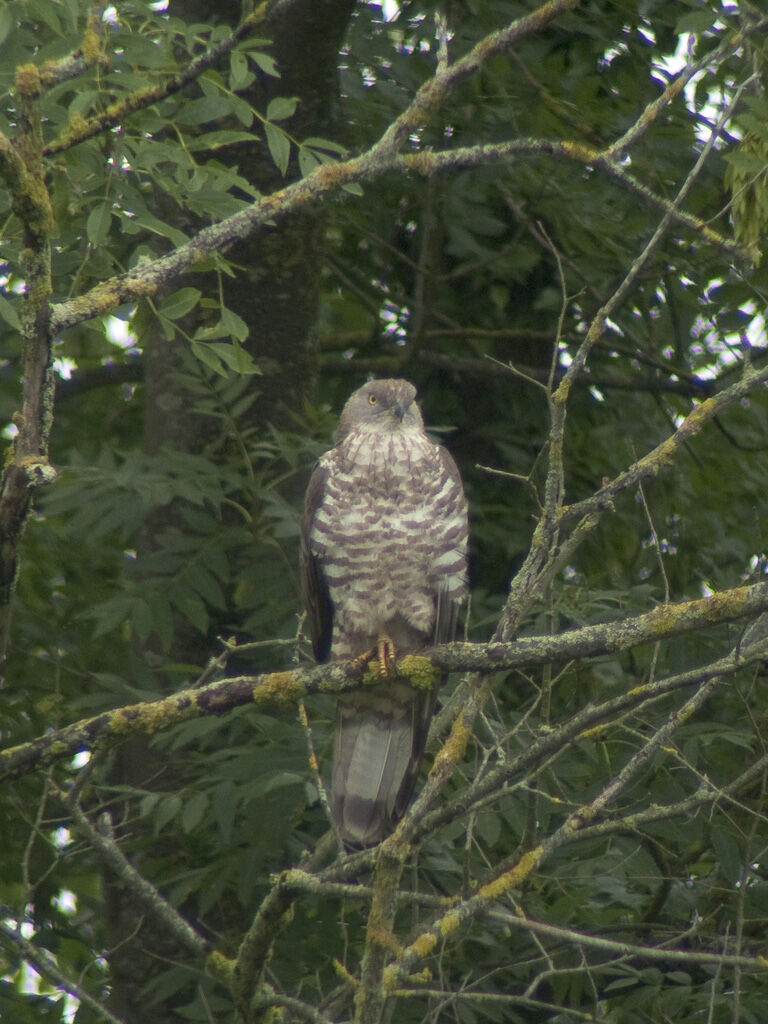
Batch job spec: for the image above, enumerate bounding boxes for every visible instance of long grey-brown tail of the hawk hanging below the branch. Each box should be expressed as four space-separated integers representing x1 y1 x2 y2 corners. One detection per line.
331 683 434 848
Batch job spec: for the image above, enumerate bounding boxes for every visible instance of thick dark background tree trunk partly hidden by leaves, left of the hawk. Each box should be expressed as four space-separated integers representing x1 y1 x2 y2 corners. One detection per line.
104 0 353 1024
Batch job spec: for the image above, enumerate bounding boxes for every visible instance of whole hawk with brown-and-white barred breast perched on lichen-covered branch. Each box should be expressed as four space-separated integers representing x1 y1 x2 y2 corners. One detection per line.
301 380 467 847
